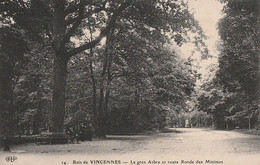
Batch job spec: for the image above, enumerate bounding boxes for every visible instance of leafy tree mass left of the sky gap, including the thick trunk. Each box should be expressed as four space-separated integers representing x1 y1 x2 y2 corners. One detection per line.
0 0 207 136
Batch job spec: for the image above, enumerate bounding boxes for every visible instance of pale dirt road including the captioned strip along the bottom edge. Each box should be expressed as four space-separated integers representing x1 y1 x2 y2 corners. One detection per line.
0 128 260 165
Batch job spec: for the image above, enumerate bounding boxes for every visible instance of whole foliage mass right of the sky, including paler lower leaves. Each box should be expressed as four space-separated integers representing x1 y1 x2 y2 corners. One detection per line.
200 0 260 129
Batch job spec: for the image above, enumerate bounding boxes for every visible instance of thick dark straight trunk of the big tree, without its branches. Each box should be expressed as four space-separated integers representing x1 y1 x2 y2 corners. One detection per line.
52 0 68 132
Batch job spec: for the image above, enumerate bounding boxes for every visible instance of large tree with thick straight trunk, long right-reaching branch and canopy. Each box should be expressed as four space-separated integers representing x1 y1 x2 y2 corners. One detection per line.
0 0 206 132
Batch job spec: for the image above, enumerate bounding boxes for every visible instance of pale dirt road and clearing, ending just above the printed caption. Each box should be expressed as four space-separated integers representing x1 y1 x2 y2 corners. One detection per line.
0 128 260 155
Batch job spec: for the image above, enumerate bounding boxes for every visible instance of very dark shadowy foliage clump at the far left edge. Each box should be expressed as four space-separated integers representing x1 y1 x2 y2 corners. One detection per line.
0 26 27 135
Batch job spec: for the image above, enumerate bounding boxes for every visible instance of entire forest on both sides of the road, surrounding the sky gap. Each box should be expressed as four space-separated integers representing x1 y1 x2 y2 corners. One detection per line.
0 0 260 149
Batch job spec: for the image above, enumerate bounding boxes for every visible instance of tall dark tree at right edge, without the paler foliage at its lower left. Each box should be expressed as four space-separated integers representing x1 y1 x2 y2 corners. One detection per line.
217 0 260 127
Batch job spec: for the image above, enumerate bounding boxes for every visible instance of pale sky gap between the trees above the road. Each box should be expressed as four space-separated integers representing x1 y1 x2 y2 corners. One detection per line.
180 0 223 77
